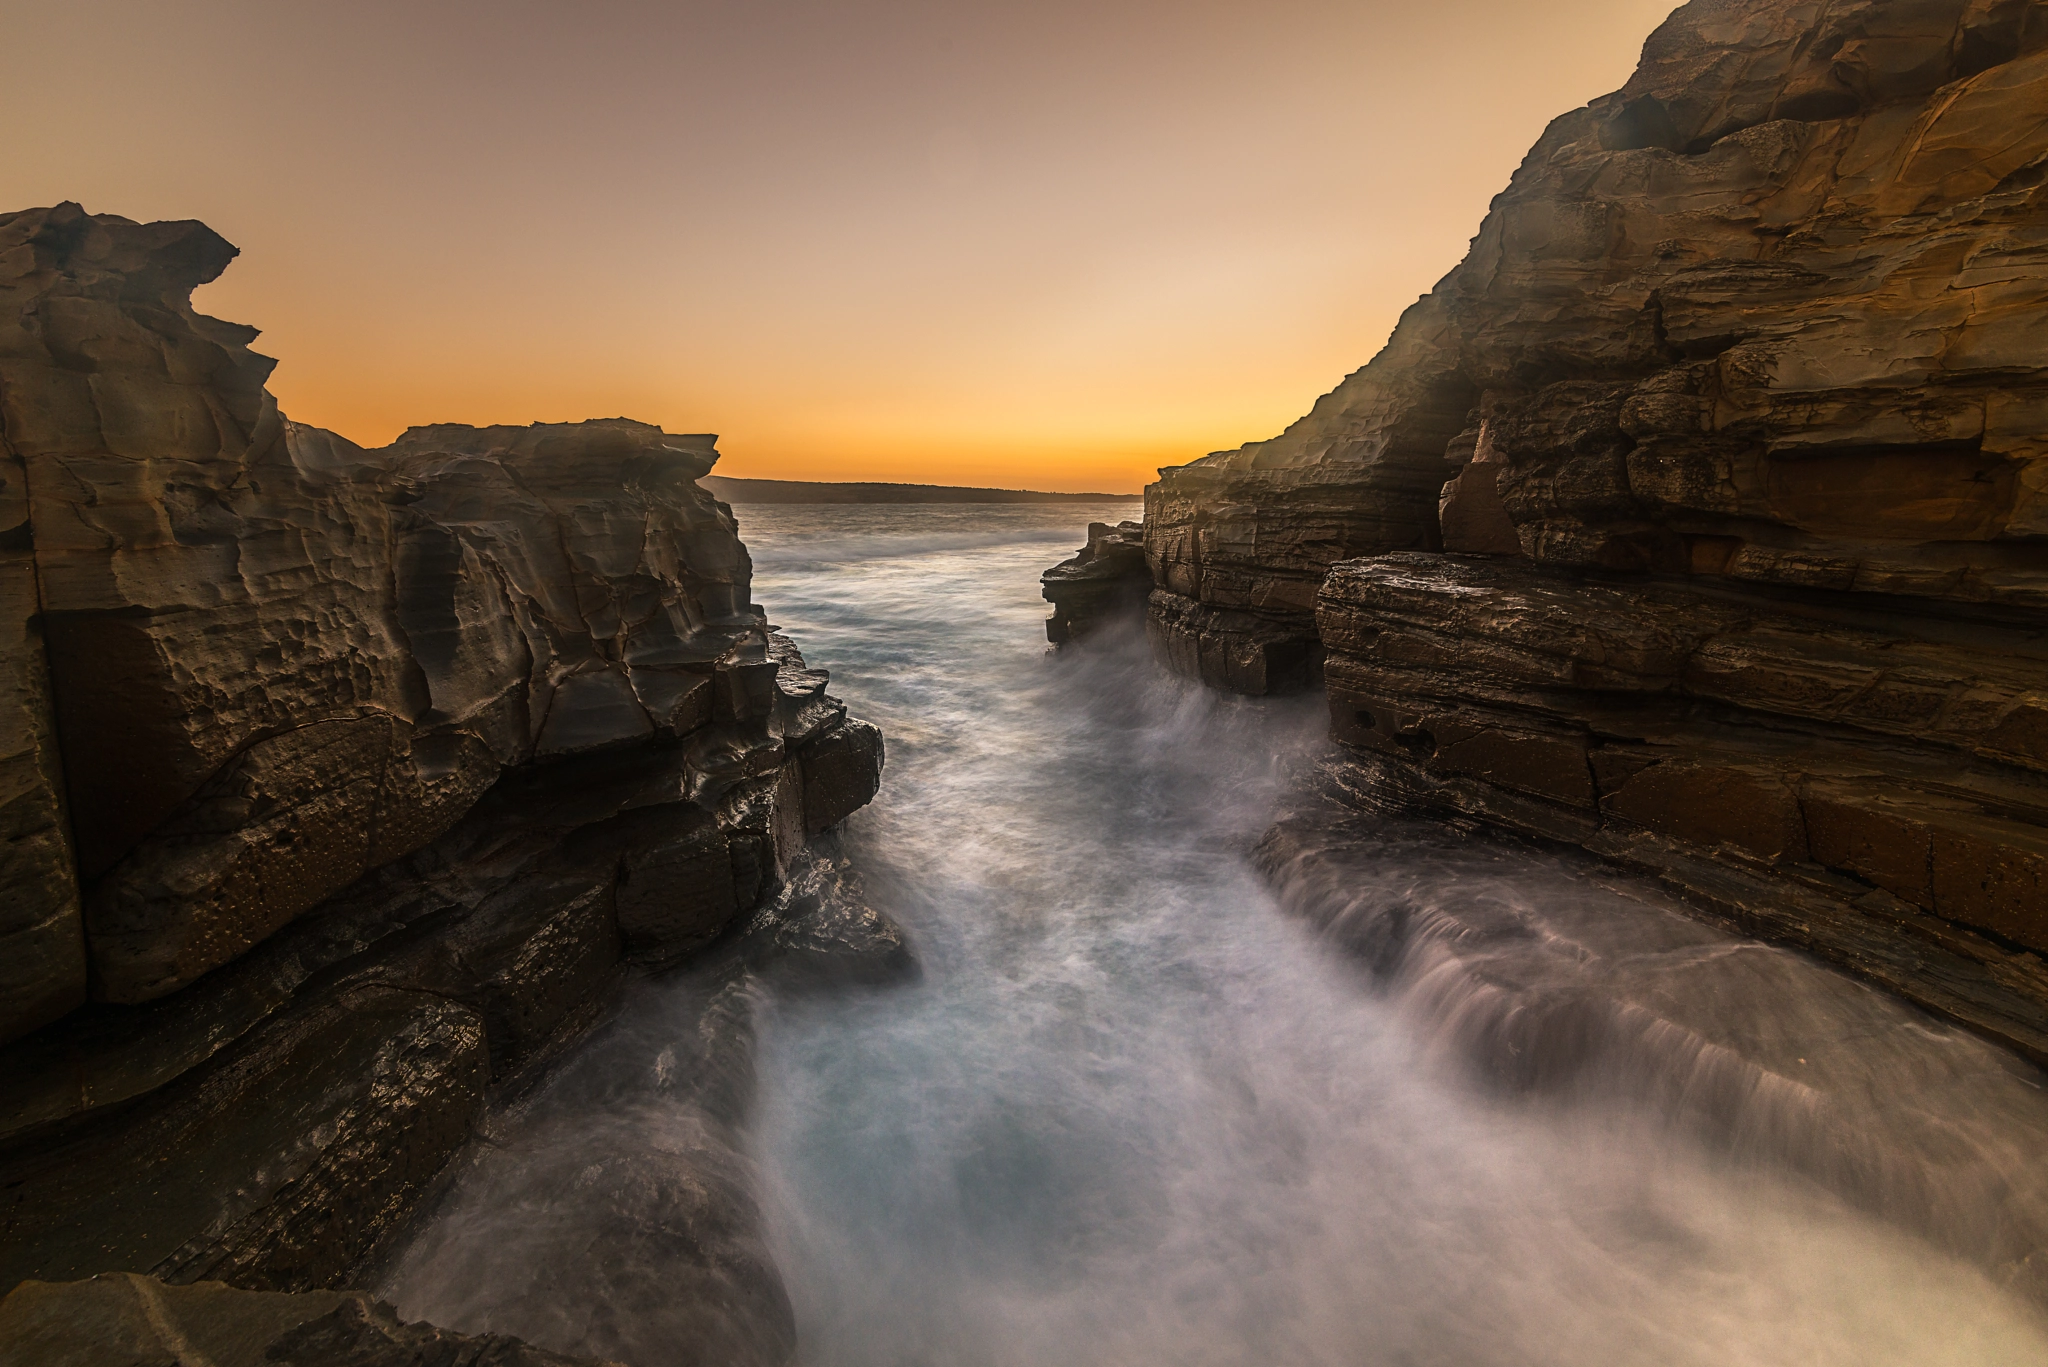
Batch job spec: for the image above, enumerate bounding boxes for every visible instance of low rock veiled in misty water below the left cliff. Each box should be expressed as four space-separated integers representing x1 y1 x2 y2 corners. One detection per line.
381 851 918 1367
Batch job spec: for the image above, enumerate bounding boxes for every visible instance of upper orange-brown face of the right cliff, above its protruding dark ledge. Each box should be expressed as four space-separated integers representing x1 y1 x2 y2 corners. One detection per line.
1147 0 2048 687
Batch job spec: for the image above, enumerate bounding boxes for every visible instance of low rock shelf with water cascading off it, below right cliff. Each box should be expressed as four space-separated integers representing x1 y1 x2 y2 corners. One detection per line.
1253 791 2048 1301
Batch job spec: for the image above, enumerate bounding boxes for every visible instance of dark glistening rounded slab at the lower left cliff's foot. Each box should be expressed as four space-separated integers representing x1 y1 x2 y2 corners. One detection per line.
0 984 489 1291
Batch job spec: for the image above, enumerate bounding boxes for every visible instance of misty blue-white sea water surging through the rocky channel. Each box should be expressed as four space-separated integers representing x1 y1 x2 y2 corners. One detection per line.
387 504 2048 1367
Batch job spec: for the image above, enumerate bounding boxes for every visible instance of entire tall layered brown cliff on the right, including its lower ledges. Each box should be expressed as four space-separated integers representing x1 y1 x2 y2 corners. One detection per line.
1145 0 2048 1058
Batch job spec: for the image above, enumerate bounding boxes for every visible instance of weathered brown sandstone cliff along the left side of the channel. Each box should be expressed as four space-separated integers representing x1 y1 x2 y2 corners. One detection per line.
0 205 883 1289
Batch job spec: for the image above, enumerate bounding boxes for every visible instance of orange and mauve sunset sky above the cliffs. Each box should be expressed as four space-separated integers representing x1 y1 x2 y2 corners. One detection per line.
0 0 1671 492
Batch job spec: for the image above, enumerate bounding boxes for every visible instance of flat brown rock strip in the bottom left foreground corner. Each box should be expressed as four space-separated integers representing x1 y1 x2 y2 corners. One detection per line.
0 1273 598 1367
